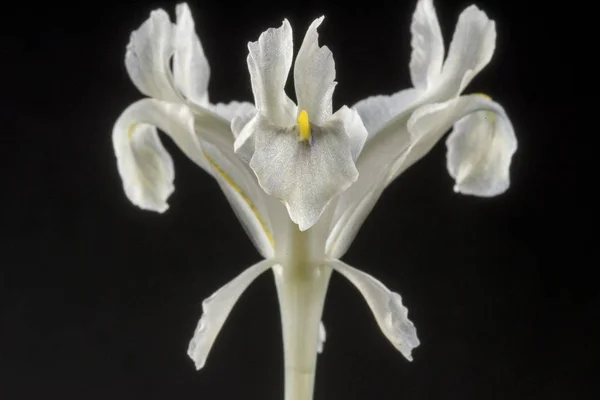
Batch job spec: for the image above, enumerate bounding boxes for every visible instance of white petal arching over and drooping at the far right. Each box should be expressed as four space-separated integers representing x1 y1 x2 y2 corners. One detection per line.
391 95 517 196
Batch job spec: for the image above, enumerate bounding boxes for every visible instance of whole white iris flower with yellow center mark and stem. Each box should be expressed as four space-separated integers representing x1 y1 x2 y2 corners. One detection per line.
113 0 517 400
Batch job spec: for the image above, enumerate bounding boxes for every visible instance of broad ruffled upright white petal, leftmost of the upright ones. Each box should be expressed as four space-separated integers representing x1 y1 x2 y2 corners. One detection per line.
125 9 180 102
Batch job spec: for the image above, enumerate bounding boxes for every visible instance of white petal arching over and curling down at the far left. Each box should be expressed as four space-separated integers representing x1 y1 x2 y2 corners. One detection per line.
112 99 207 212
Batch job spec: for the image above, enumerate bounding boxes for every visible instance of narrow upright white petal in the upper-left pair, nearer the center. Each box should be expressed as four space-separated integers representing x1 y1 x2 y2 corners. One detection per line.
173 3 210 106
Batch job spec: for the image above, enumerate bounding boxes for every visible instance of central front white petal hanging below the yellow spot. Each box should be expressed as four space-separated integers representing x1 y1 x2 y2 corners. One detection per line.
246 115 358 231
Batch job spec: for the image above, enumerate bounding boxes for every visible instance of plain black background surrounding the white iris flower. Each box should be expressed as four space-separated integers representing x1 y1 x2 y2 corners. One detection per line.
0 0 600 400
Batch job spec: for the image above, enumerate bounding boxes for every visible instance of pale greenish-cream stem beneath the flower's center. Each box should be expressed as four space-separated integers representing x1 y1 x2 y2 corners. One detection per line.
274 225 331 400
